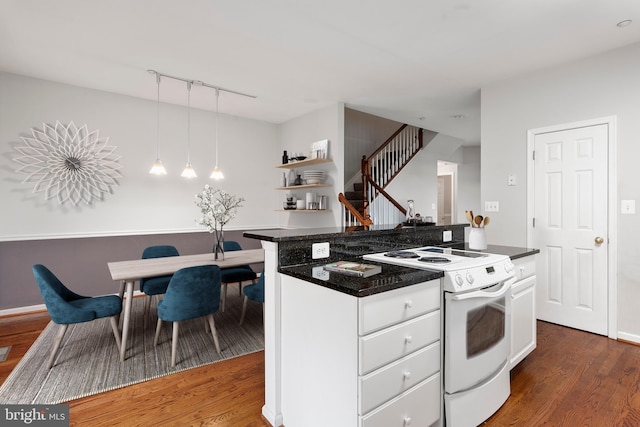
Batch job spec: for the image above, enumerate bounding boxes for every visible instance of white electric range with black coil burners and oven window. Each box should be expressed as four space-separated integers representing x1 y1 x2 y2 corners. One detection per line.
363 246 516 427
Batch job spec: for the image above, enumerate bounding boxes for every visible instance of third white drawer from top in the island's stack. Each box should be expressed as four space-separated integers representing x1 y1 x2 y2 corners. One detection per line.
359 341 440 415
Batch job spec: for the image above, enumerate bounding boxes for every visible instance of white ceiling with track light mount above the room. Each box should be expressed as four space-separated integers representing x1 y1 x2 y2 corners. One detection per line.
0 0 640 145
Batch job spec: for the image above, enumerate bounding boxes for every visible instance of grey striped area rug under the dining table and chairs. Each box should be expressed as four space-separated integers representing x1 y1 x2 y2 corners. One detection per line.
0 286 264 404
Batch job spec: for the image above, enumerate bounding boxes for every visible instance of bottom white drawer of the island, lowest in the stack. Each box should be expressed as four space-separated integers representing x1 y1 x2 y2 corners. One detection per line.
360 373 440 427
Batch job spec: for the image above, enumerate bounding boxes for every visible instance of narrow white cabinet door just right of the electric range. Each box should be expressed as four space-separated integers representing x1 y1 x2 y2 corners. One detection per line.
510 255 536 369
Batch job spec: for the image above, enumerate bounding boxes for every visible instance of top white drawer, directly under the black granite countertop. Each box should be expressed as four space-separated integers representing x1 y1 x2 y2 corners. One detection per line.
358 279 441 335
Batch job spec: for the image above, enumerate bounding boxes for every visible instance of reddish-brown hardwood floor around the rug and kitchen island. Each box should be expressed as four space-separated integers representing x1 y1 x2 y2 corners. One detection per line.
0 312 640 427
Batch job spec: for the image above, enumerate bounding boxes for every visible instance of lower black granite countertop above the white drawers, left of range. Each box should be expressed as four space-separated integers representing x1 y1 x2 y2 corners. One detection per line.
278 258 444 297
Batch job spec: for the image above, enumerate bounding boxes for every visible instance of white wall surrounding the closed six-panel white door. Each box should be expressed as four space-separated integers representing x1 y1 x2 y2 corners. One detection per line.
481 44 640 341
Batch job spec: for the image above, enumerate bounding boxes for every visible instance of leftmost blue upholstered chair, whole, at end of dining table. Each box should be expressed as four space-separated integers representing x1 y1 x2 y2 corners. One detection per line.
32 264 122 369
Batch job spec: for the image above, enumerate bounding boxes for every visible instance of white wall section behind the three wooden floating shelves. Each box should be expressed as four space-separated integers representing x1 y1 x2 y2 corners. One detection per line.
276 104 344 228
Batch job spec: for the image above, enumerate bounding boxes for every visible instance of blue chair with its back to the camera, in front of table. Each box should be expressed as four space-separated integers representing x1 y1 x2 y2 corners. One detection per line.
153 265 220 367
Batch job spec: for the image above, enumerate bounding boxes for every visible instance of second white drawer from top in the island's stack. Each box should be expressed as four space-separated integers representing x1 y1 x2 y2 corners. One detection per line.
358 310 440 375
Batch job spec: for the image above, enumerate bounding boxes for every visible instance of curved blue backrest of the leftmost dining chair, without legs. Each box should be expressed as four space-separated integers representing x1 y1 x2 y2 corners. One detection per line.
31 264 95 324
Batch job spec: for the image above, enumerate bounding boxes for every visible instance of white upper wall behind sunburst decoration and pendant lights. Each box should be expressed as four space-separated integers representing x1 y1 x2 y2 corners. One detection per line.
0 73 282 240
